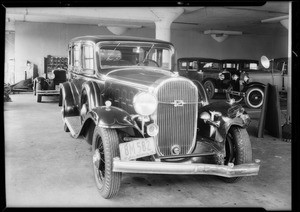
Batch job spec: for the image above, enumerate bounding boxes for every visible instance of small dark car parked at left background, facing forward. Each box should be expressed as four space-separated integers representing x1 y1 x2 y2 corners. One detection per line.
33 67 67 102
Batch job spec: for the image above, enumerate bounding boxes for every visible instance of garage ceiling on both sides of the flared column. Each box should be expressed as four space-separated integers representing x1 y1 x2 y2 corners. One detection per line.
6 2 289 35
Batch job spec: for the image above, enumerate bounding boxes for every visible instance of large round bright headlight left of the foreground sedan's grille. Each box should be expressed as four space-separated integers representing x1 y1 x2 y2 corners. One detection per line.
133 92 158 116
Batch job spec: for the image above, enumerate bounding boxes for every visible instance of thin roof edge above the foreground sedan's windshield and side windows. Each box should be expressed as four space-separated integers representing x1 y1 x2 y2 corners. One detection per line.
70 35 173 45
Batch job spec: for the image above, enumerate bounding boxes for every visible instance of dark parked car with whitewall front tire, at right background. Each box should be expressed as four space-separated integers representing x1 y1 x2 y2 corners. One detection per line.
223 59 283 108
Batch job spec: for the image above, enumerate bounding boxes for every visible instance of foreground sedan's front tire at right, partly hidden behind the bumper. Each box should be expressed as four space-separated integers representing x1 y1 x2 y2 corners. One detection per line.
221 126 252 183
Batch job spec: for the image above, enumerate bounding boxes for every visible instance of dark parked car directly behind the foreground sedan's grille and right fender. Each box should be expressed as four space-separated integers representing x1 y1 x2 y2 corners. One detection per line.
177 57 231 99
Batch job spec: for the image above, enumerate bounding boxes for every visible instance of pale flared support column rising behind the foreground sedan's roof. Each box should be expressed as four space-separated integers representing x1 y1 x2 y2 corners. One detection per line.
151 8 184 42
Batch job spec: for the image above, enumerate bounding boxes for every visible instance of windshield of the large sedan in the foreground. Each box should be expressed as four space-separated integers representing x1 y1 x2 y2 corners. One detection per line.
99 41 174 70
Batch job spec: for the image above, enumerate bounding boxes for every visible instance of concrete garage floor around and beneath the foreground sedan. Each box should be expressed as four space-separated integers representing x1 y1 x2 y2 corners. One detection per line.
4 93 291 210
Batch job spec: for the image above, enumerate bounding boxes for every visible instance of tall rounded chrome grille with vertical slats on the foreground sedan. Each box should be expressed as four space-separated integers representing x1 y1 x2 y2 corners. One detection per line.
155 78 198 156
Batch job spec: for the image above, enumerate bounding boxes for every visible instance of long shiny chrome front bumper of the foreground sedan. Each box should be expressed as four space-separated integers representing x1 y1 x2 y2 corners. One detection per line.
113 158 259 177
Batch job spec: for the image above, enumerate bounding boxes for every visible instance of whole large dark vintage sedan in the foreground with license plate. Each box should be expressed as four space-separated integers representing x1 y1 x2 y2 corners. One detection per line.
59 36 259 198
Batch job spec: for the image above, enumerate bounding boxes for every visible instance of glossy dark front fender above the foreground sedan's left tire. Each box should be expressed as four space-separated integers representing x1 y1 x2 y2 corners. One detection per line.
86 106 135 128
